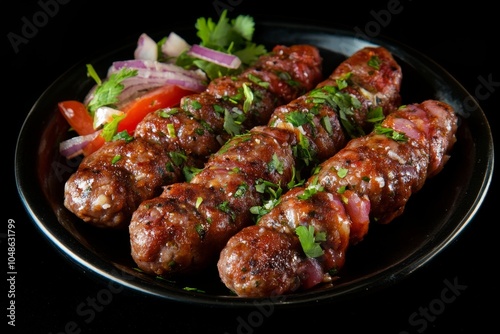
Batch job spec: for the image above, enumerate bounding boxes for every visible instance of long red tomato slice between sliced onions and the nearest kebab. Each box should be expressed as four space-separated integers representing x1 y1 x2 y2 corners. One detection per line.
117 85 193 135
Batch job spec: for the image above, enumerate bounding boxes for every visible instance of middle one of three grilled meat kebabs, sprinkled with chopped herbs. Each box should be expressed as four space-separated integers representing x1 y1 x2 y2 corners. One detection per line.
129 48 402 276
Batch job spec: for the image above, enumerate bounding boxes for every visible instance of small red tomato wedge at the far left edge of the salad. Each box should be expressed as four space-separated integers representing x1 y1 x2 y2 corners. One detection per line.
57 100 95 136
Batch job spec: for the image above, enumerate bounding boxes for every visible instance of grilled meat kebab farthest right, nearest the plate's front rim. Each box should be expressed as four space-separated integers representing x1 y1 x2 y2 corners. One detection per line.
218 100 457 297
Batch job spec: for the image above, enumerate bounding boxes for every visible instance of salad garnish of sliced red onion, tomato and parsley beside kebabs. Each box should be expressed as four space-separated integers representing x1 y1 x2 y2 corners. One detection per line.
58 10 267 158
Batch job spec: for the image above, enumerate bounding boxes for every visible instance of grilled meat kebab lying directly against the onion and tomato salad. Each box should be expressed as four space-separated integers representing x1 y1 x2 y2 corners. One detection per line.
64 45 322 229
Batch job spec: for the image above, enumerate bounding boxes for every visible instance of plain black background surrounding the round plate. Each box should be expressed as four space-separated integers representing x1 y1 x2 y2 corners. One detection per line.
0 0 500 334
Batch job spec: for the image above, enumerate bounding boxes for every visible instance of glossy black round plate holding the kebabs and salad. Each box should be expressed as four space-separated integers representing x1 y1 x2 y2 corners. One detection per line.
15 23 494 306
